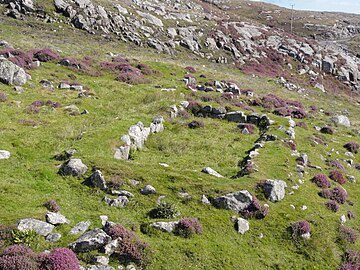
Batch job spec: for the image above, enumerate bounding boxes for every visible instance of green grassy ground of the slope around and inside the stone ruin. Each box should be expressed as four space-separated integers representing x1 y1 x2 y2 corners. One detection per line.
0 15 360 269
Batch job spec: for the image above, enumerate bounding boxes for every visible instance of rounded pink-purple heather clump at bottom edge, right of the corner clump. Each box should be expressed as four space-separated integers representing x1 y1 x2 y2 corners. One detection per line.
40 248 80 270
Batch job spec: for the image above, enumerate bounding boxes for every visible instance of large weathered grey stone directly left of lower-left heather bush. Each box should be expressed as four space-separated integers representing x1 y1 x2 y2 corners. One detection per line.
70 229 111 252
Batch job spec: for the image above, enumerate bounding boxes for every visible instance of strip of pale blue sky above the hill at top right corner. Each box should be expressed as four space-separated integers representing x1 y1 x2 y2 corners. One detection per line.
252 0 360 14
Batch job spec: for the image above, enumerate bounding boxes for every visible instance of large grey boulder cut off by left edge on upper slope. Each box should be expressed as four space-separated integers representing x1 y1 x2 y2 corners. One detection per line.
0 58 27 86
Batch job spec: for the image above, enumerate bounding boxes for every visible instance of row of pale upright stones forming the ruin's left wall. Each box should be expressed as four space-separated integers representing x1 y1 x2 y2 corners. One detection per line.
114 116 164 160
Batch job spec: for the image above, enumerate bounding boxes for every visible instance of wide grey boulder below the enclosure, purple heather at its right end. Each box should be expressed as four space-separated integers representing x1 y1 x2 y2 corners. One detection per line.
212 190 253 212
